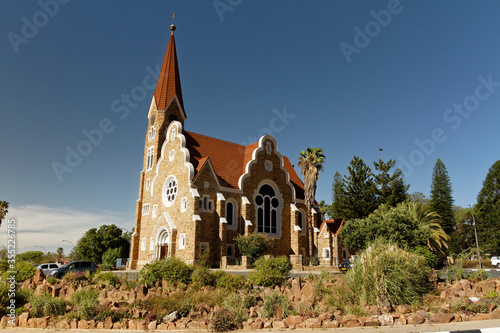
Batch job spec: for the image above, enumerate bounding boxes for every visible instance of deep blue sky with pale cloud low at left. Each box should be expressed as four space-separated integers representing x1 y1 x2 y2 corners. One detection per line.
0 0 500 253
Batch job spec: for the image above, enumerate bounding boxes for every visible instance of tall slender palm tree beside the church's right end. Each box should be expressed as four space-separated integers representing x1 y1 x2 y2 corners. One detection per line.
298 147 326 258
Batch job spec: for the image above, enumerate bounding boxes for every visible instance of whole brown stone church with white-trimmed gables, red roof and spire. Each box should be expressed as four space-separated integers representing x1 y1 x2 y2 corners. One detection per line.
128 25 317 269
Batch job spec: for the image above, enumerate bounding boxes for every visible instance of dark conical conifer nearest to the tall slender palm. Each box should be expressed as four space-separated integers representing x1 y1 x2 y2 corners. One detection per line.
337 156 378 220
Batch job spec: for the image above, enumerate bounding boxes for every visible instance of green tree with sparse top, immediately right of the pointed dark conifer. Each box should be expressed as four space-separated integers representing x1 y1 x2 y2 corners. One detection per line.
373 159 410 207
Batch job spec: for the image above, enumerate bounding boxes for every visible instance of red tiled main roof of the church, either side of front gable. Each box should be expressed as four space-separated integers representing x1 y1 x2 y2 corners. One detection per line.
184 131 304 199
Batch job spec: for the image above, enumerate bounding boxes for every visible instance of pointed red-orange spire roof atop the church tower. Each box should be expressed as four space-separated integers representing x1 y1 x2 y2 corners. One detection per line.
153 27 184 112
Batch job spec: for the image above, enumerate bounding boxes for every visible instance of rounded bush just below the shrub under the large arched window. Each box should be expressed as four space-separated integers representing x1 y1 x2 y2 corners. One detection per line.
250 257 292 288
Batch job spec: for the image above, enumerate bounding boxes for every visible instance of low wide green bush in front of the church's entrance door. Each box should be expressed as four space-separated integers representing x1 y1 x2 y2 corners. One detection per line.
140 257 193 284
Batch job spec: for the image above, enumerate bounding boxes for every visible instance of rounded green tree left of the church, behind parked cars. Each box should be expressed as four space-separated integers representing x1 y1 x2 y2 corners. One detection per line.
75 224 130 264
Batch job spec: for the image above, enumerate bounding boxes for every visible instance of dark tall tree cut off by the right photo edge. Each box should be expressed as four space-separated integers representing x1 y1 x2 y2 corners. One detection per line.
475 160 500 255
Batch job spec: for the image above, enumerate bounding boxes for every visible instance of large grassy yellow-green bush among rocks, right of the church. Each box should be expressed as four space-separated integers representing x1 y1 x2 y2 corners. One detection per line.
346 241 431 305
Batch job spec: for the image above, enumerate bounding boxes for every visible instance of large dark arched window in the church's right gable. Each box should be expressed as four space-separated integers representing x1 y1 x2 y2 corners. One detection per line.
255 184 280 235
